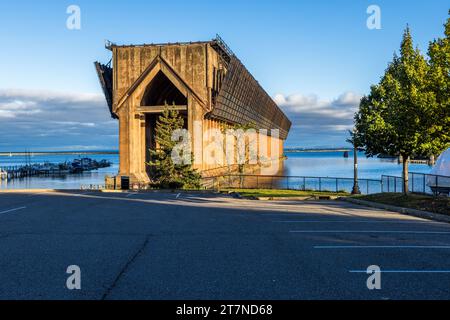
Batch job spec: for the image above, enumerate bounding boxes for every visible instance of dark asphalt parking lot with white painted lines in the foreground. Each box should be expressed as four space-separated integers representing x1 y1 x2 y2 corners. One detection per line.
0 191 450 299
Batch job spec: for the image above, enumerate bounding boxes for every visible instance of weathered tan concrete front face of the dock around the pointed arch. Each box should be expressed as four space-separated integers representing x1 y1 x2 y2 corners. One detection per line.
112 43 283 183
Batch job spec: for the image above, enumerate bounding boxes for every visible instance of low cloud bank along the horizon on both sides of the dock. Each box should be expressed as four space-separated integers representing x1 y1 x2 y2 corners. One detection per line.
0 89 360 151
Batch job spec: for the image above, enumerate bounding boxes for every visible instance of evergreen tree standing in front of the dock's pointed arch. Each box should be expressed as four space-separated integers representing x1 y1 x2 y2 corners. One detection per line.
148 105 201 189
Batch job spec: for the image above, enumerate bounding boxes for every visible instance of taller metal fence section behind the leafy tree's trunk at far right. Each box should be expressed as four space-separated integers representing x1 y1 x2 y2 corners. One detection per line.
381 172 450 195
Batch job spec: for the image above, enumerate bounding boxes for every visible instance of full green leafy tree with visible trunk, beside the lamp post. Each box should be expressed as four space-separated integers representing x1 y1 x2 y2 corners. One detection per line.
355 27 436 193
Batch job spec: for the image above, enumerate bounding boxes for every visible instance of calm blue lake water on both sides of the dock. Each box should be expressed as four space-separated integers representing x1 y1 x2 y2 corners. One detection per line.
0 152 431 189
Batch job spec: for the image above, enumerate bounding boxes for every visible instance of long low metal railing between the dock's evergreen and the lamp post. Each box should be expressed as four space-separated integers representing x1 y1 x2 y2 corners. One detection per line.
202 175 382 194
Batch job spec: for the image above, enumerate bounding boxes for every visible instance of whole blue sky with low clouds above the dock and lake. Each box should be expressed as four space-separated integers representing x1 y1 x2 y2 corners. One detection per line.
0 0 450 151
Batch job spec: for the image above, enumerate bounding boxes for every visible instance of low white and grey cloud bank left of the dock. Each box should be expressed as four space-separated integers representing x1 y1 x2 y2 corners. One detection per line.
0 89 118 151
